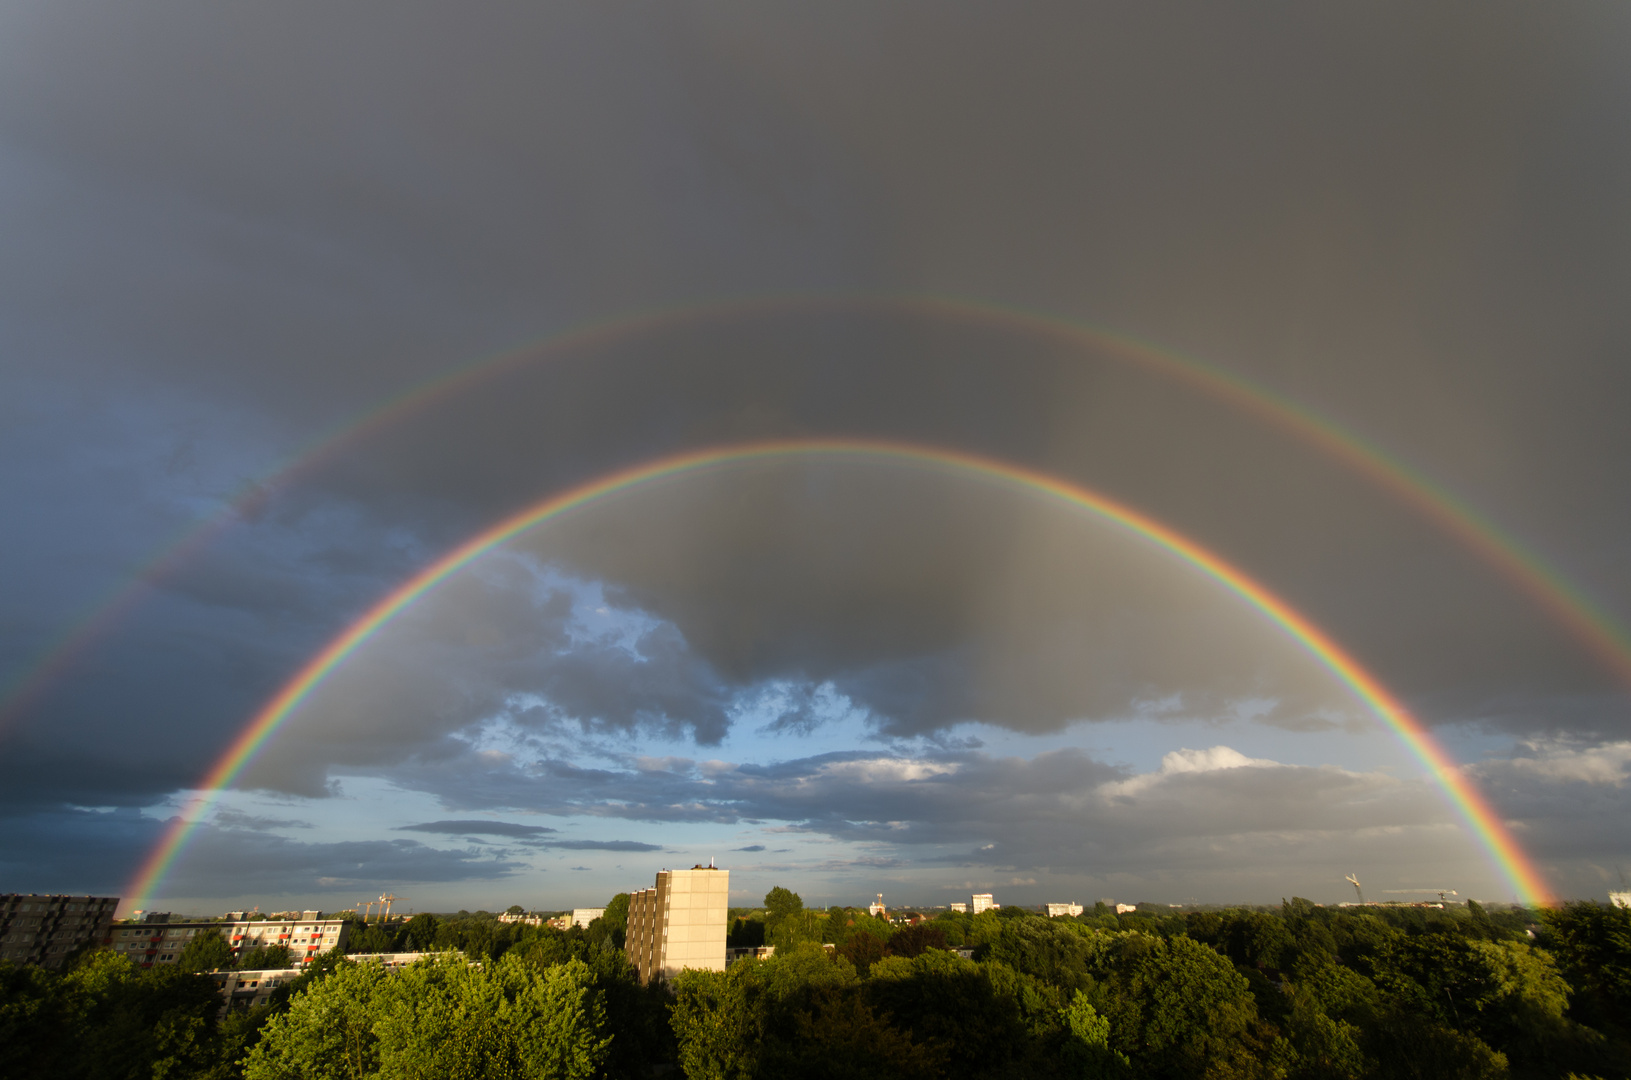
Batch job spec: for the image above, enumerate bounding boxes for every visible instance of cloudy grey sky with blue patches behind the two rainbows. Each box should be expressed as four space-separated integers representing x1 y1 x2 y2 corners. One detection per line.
0 0 1631 905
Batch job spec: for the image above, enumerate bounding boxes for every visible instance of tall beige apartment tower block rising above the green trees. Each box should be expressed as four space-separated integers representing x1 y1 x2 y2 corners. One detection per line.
623 866 731 982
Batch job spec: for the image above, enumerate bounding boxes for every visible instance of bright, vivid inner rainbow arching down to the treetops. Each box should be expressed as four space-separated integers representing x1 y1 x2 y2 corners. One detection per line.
127 439 1551 907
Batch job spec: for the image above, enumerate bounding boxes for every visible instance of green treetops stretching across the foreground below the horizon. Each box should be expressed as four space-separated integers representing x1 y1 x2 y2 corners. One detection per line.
0 889 1631 1080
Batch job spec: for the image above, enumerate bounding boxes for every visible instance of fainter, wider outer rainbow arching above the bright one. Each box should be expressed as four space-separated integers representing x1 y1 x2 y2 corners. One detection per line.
12 295 1631 731
